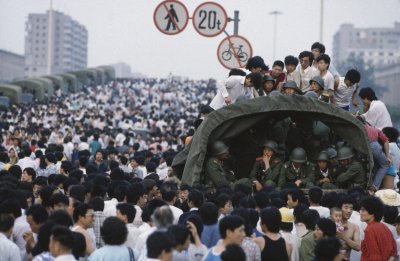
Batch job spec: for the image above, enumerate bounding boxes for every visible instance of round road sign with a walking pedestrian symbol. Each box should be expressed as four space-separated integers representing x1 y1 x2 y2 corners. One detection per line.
153 0 189 35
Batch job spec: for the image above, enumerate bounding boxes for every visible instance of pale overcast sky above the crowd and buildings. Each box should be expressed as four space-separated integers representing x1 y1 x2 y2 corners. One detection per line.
0 0 400 79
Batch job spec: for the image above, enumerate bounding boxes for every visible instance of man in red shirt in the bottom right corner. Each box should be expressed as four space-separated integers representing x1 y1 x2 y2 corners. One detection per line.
360 196 397 261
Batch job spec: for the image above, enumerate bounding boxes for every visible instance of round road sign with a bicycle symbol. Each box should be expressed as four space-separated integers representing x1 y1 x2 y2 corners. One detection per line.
217 35 253 69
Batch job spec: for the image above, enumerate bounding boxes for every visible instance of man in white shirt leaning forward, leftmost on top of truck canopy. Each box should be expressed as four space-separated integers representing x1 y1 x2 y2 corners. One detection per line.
210 73 262 110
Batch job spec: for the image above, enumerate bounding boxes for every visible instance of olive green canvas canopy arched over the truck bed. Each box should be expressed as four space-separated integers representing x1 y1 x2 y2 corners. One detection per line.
172 95 373 185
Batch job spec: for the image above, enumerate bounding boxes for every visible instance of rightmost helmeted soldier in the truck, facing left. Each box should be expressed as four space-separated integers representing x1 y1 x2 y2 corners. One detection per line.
336 146 367 189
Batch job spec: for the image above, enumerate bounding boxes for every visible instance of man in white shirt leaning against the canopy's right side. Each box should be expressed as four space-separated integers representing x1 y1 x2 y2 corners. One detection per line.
359 87 393 130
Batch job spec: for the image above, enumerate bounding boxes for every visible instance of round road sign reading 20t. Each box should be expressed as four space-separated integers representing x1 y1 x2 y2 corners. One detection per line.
192 2 228 37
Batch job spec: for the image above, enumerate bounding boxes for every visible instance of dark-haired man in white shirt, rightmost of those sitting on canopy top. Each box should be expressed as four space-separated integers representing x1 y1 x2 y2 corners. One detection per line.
333 69 361 111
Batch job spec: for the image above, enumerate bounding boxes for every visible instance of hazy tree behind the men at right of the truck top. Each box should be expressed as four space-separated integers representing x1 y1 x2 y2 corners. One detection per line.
337 53 388 98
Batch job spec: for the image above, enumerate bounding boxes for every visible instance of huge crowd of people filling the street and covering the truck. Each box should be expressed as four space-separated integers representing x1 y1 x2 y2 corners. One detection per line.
0 40 400 261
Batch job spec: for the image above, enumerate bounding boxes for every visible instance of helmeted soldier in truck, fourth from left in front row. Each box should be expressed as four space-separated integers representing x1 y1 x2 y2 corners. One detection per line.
314 151 337 189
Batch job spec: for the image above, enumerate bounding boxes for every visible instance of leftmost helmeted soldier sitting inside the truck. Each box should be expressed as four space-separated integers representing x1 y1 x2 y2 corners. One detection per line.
205 141 251 189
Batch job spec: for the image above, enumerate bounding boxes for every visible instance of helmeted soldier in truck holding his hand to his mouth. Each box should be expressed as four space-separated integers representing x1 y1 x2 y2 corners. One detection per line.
249 140 283 189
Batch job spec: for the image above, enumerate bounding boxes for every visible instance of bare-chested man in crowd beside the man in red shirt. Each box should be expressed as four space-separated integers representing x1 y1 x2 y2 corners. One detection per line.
337 196 361 260
